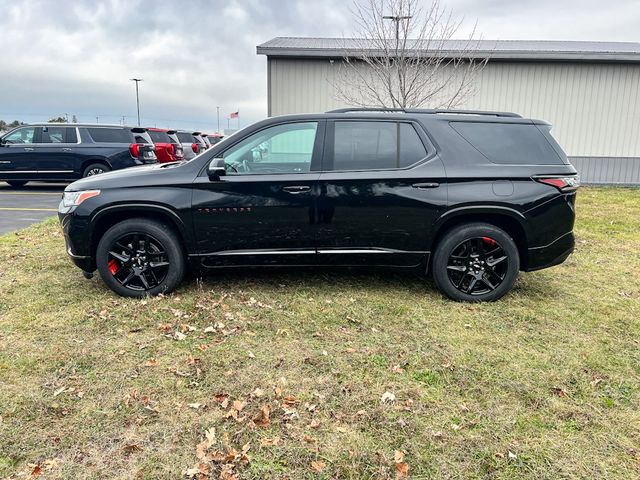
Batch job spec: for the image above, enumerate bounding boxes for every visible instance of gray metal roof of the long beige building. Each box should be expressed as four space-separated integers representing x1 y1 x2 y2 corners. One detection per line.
257 37 640 63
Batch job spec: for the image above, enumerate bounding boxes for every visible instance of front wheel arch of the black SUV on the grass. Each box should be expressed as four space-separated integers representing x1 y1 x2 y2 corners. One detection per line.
90 204 190 258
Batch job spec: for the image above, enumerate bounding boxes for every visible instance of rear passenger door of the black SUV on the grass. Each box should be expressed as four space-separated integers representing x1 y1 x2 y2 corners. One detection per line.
314 119 447 266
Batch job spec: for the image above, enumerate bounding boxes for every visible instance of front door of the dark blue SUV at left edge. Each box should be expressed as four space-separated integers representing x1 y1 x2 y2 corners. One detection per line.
0 127 38 180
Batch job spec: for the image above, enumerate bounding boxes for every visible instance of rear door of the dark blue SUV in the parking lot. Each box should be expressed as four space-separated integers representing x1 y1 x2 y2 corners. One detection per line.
34 125 82 180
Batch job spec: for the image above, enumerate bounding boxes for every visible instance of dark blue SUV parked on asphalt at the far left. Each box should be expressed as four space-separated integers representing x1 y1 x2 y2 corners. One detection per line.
0 123 157 187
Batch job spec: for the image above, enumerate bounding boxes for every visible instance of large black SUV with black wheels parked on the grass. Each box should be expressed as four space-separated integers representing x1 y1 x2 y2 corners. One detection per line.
59 109 578 301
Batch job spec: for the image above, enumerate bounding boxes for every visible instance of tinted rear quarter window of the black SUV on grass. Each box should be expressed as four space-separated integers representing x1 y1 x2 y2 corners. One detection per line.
451 122 566 165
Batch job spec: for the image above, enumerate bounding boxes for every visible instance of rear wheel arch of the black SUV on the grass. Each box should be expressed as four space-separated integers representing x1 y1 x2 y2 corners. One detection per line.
428 207 529 270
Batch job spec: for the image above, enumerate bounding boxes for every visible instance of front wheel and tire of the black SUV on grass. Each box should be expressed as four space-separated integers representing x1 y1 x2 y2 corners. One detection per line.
96 218 186 298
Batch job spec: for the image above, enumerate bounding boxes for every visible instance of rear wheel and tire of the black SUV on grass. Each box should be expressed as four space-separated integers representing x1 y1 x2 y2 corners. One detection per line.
432 223 520 302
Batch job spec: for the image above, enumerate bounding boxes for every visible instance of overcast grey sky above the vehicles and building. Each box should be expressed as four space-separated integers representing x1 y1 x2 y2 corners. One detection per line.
0 0 640 131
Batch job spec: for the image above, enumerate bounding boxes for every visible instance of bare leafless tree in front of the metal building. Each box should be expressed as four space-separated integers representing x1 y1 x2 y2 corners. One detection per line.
332 0 488 108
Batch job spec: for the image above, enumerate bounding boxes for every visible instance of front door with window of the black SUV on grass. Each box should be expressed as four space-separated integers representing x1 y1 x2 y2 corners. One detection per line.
193 121 324 267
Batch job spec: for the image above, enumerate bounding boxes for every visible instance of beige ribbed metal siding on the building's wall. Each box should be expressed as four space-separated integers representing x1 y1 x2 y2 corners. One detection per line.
269 58 640 158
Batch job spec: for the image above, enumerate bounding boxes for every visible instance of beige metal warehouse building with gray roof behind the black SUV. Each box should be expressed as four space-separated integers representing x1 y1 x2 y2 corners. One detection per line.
257 38 640 184
